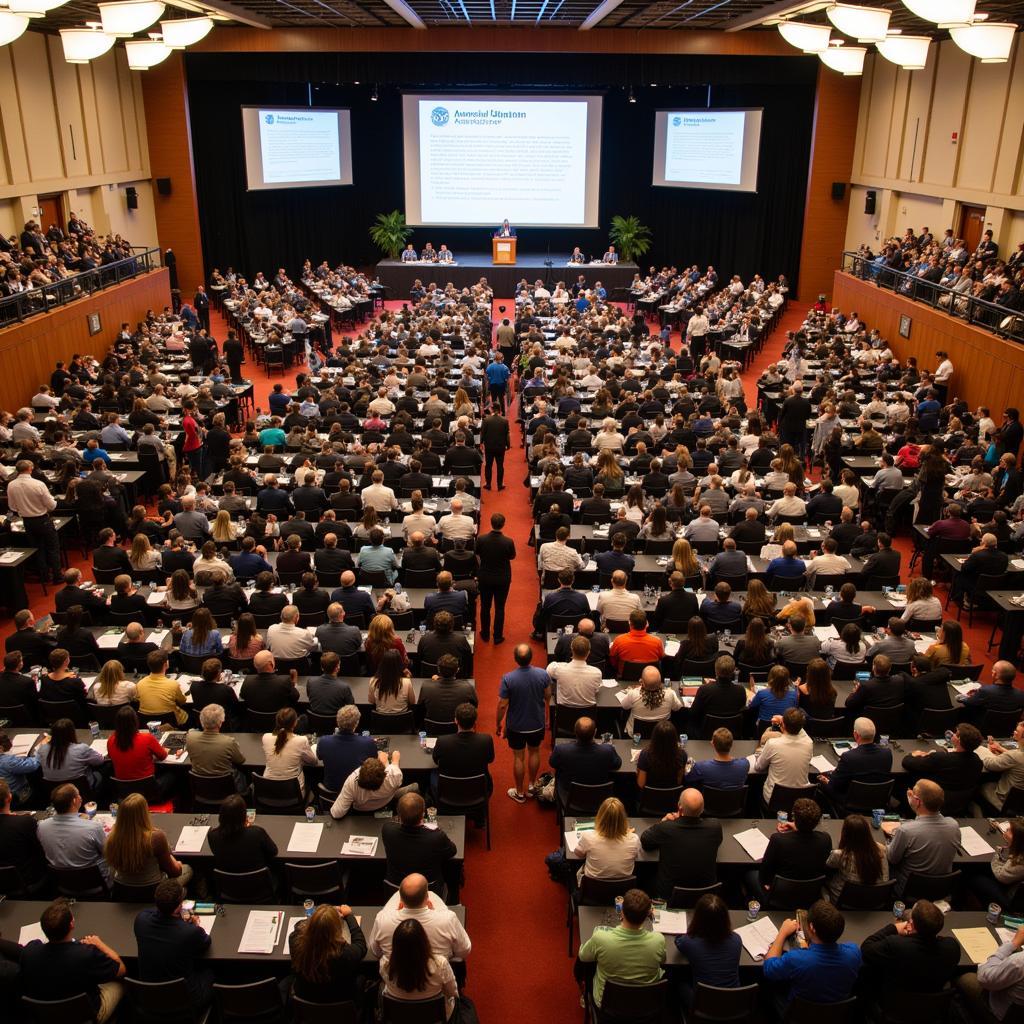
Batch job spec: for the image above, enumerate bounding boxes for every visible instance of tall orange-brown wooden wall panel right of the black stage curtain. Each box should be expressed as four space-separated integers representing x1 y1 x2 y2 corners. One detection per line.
797 65 860 301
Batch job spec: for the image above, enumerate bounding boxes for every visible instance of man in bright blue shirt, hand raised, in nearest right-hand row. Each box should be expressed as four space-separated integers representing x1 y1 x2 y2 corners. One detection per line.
764 899 860 1017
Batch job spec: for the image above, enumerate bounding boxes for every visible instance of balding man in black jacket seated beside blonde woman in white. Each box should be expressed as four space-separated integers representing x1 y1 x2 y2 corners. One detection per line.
640 790 722 899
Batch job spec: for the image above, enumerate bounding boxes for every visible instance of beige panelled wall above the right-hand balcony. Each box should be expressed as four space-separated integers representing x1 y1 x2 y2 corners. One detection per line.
846 35 1024 252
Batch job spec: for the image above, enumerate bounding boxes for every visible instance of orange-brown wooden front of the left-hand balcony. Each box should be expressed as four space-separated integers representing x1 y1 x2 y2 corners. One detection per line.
0 269 171 419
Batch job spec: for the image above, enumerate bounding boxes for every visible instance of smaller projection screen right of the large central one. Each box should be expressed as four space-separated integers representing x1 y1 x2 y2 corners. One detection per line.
651 110 761 191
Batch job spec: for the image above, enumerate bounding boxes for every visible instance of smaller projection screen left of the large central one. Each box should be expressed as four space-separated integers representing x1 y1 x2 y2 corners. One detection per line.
242 106 352 190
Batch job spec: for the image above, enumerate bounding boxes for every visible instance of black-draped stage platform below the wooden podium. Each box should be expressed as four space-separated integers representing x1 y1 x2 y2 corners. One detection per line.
377 253 637 299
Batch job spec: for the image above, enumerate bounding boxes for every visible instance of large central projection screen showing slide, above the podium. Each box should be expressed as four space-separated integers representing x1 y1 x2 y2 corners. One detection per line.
402 93 602 229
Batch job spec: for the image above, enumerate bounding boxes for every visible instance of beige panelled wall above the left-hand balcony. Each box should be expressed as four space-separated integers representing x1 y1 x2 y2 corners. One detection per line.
0 32 157 246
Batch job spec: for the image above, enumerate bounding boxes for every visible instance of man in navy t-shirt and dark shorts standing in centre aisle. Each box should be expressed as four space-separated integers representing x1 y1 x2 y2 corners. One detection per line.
495 643 551 804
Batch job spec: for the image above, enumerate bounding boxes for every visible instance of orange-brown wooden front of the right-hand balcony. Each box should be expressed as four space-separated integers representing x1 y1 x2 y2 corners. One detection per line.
833 270 1024 421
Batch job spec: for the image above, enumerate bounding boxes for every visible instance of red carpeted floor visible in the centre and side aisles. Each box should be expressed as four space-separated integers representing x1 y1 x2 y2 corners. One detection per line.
0 299 1007 1021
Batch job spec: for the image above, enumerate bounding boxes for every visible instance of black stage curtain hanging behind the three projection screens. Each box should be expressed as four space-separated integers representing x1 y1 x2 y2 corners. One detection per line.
185 51 818 292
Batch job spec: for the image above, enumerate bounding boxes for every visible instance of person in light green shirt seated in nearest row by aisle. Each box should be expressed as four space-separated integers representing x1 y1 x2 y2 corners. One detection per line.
580 889 665 1007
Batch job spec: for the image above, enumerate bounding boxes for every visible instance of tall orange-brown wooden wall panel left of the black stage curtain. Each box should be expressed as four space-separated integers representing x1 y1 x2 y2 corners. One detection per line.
142 52 204 297
